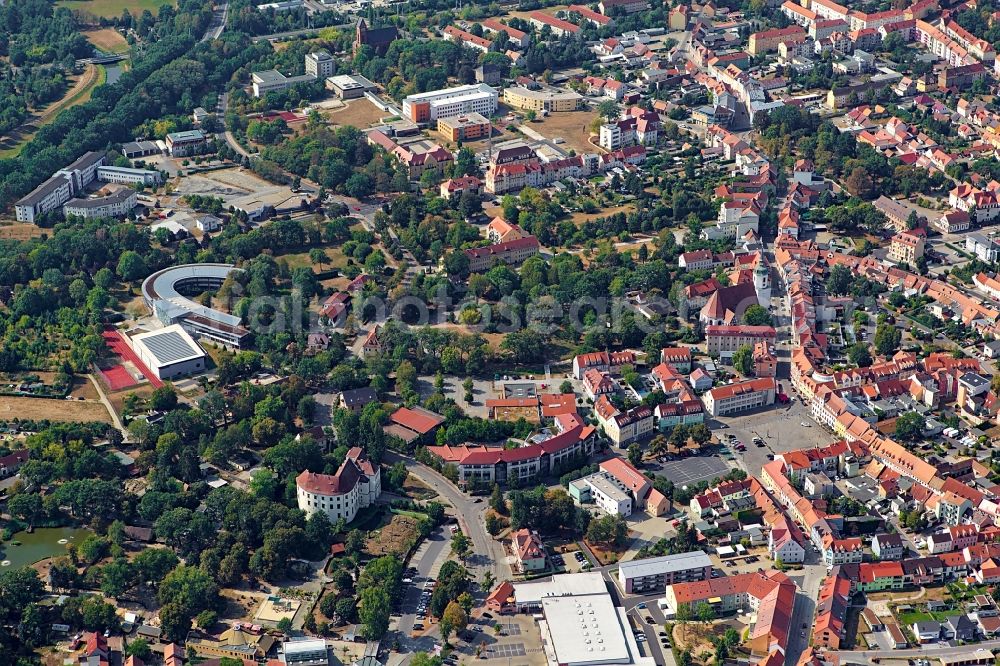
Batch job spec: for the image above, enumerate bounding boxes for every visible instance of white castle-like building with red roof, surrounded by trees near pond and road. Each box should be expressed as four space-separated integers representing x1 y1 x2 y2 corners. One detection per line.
295 446 382 523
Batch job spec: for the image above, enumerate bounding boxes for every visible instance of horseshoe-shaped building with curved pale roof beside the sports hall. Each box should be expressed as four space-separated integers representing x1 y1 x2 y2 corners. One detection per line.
142 264 250 347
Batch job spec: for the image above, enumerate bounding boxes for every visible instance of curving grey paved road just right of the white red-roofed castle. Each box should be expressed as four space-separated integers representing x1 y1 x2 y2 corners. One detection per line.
385 451 511 581
